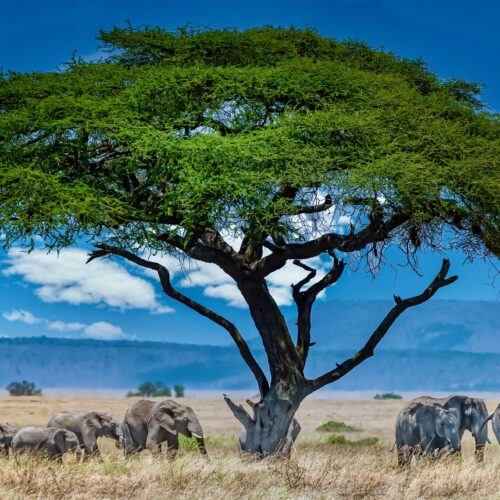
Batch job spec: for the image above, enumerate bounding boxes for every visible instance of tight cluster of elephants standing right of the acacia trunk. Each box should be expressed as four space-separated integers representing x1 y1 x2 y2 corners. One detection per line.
396 396 500 465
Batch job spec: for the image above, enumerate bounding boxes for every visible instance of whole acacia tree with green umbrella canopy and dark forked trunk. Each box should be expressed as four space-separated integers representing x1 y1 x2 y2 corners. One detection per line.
0 27 500 454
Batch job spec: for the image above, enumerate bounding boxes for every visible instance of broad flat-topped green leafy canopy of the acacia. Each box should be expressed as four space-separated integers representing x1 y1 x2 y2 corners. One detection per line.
0 27 500 255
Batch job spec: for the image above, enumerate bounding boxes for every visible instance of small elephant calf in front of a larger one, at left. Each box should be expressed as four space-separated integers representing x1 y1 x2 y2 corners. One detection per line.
12 427 82 460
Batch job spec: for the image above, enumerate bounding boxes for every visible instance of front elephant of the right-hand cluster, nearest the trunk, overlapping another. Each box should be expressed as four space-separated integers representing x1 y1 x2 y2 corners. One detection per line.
396 403 461 465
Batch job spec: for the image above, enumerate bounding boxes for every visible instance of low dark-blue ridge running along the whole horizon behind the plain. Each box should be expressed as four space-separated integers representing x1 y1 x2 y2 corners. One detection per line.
0 337 500 391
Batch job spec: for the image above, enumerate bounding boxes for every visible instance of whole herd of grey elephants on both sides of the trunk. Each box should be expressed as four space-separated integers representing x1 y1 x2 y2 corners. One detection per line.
0 396 500 465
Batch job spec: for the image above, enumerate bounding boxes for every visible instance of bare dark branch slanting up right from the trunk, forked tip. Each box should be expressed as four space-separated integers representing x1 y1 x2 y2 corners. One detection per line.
308 259 458 393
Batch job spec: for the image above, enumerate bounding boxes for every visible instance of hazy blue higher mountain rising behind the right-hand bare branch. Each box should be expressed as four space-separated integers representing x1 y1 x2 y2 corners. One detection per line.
280 300 500 354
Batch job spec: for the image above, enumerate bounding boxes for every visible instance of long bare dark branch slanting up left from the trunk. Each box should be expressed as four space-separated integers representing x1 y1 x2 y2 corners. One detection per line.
87 245 269 397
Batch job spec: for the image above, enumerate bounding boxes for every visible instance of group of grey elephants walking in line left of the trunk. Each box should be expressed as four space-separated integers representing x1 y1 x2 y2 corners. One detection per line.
0 400 206 460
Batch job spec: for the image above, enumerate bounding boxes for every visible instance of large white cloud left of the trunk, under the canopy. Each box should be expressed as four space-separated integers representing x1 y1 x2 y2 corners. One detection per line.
3 248 173 313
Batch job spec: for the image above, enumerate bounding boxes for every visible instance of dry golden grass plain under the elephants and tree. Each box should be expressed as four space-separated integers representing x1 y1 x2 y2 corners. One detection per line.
0 398 500 500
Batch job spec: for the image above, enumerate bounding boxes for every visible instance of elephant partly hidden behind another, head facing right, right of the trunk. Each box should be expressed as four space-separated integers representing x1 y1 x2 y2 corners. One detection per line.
413 396 488 461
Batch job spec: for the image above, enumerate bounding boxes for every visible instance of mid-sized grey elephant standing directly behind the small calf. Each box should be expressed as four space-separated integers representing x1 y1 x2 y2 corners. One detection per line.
47 411 123 459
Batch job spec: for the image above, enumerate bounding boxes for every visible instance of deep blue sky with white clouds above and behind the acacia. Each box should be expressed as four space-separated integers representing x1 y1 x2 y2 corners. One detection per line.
0 0 500 344
